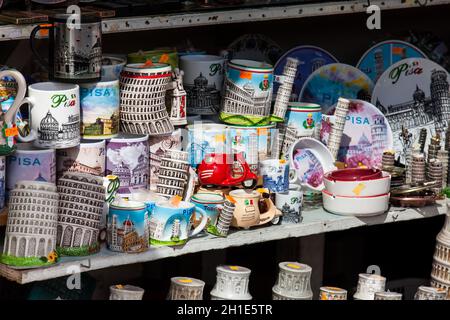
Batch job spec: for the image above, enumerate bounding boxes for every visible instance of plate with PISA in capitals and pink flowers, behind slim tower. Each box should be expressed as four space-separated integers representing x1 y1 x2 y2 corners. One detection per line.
320 99 394 168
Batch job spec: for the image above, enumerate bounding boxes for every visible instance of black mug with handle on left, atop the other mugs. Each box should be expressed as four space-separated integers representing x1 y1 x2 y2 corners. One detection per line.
30 14 102 83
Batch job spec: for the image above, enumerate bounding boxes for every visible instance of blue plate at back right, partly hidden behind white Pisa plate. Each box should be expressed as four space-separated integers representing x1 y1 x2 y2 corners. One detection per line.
356 40 427 83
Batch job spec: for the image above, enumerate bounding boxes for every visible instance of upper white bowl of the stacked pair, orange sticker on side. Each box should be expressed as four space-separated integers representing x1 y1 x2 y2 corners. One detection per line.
323 171 391 197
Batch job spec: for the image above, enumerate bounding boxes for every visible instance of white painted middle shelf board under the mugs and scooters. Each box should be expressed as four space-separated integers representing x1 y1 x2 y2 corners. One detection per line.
0 200 447 284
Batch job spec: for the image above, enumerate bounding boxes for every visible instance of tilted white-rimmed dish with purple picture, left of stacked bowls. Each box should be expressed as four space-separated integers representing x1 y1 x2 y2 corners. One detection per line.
289 138 336 191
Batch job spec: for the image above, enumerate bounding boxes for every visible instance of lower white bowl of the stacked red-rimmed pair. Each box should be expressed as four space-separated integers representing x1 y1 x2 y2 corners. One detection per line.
322 190 390 217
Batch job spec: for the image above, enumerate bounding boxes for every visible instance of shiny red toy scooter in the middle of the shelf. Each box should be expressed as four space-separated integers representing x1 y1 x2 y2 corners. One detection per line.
198 153 258 188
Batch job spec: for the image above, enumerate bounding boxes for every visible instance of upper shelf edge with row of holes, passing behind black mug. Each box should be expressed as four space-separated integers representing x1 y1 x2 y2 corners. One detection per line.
0 0 450 41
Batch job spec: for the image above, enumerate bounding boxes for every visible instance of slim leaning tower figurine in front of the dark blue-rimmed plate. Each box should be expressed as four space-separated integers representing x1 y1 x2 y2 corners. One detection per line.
273 58 299 122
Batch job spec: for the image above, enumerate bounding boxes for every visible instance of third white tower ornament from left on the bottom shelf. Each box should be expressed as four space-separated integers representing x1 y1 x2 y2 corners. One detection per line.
211 266 252 300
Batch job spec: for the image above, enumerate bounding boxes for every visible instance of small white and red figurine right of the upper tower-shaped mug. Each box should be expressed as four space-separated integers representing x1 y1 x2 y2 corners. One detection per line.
167 68 187 125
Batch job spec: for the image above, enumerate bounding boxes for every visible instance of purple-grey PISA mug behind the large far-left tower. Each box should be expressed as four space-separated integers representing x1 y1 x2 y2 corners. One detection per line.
6 143 56 192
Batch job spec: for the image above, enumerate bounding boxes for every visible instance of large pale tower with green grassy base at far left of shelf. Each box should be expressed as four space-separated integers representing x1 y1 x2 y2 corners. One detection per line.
0 181 58 267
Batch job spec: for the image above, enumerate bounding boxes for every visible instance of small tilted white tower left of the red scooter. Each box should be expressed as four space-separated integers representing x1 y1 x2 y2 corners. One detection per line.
156 150 189 197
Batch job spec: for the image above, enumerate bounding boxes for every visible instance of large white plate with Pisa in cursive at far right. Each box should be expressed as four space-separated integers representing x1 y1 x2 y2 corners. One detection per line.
372 58 450 161
